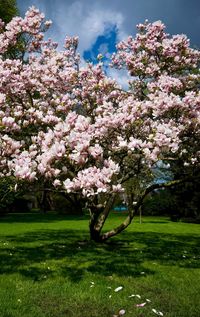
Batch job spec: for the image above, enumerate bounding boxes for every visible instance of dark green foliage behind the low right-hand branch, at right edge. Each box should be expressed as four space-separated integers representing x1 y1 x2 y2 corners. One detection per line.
142 159 200 222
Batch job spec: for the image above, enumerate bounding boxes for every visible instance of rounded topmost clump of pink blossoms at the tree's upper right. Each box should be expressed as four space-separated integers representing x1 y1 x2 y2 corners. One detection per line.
113 21 200 78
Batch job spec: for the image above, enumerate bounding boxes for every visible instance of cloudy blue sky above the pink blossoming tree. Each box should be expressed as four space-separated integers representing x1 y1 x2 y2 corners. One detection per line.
17 0 200 83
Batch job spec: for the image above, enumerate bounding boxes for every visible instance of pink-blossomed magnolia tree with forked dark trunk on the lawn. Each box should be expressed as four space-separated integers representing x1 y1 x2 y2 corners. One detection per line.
0 7 200 241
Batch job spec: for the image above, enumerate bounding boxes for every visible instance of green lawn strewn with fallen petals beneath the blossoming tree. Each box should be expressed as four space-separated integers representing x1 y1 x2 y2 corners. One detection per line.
0 214 200 317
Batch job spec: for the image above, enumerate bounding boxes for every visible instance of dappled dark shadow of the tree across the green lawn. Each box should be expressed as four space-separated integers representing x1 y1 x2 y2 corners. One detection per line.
0 230 200 282
